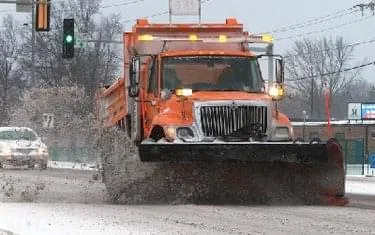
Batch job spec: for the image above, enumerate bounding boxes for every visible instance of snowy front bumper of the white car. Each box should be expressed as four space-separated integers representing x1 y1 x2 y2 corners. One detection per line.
0 154 48 166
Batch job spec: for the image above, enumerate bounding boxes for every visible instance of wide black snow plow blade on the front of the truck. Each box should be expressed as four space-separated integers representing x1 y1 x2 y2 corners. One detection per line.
139 139 348 206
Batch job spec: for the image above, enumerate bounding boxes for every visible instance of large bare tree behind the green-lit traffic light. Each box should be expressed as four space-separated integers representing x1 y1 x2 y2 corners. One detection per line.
22 0 122 114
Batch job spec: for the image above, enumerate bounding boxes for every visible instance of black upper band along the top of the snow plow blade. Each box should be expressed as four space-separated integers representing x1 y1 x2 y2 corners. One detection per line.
139 142 329 164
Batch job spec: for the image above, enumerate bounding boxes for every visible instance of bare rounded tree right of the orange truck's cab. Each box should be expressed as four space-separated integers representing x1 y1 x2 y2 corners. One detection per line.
286 37 360 118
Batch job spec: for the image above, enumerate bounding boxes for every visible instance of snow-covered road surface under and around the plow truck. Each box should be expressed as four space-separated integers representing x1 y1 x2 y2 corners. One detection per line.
0 169 375 235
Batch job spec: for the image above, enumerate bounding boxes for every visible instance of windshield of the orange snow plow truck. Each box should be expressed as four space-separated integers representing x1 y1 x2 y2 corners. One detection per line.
161 56 263 92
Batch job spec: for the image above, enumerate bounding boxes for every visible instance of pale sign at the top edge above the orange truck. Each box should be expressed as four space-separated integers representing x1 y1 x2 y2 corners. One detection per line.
169 0 201 15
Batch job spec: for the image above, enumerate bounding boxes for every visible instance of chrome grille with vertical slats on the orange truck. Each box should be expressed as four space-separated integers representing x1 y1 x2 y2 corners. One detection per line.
200 105 267 137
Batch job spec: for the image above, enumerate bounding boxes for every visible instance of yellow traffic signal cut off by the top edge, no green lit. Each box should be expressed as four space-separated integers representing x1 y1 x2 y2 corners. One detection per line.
35 0 51 31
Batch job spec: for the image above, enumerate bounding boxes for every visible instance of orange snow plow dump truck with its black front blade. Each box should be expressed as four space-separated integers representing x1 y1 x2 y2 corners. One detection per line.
99 18 347 205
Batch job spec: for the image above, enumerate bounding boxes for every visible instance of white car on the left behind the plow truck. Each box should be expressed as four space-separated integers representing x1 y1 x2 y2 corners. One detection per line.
0 127 49 169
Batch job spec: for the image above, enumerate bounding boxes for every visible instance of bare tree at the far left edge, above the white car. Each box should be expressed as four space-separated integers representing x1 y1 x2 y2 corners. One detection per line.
0 15 23 125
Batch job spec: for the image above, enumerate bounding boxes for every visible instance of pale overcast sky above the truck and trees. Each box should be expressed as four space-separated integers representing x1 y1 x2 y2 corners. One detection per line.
0 0 375 82
